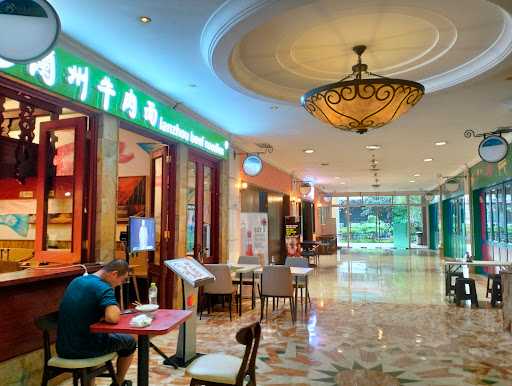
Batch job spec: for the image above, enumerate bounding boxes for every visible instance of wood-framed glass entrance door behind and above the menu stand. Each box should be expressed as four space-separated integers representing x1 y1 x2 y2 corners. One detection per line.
186 151 219 263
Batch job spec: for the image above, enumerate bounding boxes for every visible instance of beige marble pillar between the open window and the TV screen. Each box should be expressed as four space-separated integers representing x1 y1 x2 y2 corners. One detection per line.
95 114 119 261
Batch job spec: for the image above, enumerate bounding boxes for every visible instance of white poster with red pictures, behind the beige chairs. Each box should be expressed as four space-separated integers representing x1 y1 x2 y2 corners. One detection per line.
240 212 269 265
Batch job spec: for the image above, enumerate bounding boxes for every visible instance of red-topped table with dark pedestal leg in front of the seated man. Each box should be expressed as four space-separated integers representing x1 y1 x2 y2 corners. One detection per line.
90 309 192 386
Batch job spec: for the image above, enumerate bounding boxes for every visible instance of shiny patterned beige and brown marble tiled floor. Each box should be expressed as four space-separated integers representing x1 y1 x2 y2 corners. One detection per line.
59 250 512 386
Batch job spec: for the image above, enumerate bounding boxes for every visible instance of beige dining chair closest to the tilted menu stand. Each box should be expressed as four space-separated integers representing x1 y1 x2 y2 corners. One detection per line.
199 264 238 320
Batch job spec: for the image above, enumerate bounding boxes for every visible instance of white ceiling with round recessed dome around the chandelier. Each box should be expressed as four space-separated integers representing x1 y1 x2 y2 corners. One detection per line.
50 0 512 192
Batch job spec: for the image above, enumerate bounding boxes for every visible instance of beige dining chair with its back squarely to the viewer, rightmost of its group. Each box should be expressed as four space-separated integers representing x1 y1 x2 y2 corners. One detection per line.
260 265 296 323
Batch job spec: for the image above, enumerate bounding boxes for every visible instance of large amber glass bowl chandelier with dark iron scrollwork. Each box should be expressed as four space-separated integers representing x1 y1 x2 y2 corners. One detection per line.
301 46 425 134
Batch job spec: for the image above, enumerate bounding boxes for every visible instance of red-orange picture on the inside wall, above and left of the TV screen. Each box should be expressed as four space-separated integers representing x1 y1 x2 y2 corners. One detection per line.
117 176 146 223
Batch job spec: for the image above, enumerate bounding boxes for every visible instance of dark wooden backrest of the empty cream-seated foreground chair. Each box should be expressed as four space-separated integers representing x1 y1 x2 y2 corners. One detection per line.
236 322 261 385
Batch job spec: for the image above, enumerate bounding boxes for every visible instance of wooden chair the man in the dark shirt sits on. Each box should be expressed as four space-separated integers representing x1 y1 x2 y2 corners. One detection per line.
35 311 117 386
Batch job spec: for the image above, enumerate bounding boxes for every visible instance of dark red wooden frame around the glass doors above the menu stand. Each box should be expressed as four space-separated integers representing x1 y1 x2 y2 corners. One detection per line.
187 149 220 263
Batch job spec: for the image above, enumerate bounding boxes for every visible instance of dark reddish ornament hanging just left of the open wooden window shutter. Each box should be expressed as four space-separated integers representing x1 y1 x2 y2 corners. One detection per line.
15 102 36 184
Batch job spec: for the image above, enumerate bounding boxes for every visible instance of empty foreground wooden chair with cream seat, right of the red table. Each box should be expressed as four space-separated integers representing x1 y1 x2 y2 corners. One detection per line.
185 322 261 386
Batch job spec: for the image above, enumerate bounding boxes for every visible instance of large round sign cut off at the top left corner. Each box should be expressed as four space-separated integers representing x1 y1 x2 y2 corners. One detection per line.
0 0 60 63
